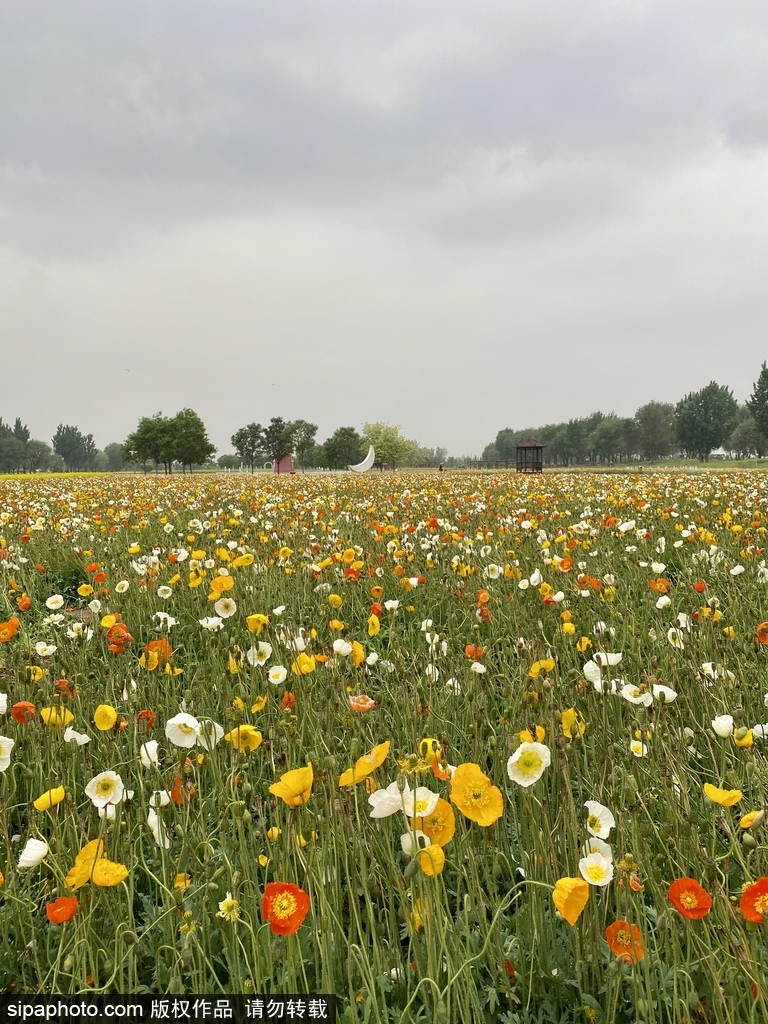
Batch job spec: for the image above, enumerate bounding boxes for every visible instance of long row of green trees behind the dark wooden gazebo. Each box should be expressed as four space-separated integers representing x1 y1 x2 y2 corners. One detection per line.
482 362 768 466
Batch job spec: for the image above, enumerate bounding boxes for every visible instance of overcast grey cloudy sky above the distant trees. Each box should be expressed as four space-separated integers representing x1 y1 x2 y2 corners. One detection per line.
0 0 768 455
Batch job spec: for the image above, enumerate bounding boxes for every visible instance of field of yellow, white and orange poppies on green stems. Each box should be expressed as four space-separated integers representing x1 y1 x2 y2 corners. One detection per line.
0 471 768 1024
